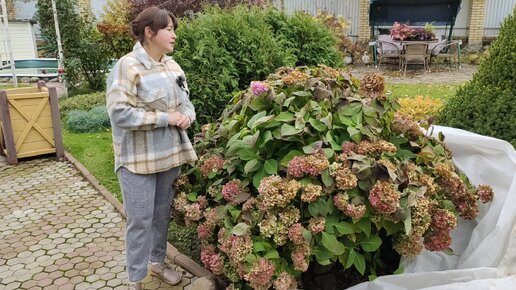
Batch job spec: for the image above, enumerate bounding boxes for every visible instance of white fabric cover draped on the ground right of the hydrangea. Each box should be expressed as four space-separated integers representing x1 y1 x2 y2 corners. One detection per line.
349 126 516 290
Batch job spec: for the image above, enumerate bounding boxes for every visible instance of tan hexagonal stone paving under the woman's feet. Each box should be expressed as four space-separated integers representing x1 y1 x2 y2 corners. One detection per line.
0 156 196 290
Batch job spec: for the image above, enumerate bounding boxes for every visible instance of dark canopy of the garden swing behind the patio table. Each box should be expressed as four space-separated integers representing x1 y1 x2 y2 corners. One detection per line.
369 0 461 39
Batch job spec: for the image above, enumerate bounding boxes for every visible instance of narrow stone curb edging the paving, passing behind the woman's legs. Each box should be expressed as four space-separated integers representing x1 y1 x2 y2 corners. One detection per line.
64 150 213 278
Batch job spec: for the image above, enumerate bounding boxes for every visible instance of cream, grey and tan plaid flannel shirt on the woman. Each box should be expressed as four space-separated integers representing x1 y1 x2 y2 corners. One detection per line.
106 42 197 174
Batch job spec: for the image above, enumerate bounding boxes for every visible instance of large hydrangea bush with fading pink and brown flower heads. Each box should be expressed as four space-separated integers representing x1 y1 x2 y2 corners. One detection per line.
174 66 493 289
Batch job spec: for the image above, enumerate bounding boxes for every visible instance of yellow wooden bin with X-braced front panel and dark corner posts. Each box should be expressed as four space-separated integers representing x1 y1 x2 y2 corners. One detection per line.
0 82 64 164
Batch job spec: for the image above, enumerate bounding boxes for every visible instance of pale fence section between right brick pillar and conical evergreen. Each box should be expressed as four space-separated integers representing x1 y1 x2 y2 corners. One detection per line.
484 0 516 36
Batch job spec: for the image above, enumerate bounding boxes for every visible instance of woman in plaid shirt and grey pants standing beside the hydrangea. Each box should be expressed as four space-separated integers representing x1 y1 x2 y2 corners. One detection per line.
107 7 197 289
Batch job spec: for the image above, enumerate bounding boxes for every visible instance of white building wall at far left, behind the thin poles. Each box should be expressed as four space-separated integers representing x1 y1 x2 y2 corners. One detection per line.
0 21 37 60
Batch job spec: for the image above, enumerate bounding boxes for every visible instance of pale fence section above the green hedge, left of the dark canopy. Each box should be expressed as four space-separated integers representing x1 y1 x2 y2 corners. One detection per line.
272 0 360 38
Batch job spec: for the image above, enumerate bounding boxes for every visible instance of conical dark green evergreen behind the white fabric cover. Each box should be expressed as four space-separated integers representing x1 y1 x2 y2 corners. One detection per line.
439 9 516 146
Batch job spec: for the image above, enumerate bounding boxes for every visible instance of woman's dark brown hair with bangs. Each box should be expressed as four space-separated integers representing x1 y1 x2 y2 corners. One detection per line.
131 6 178 44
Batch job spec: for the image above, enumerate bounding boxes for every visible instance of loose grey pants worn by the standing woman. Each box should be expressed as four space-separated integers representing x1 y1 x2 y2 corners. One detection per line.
117 167 180 282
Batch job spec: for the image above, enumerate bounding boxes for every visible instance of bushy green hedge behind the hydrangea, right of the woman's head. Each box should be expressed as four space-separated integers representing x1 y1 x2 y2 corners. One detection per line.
174 6 342 130
